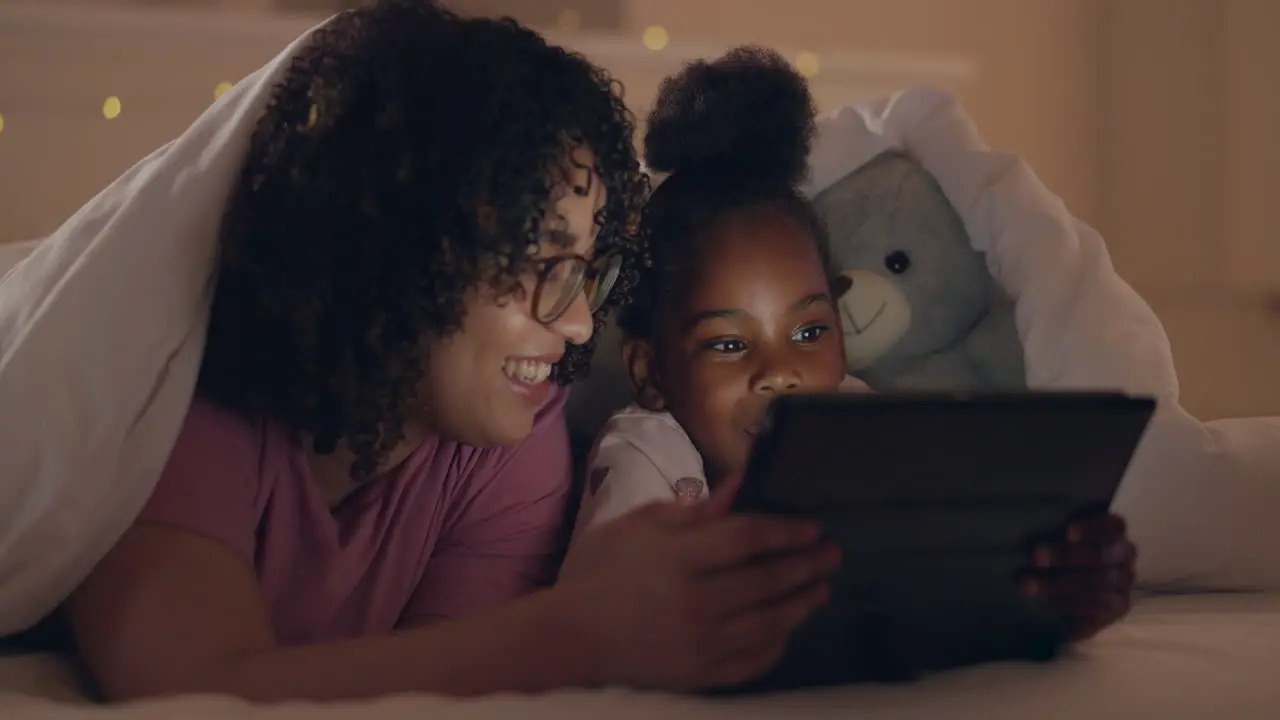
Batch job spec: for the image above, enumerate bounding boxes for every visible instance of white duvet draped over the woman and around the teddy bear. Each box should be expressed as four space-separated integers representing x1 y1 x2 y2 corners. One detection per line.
0 16 1280 635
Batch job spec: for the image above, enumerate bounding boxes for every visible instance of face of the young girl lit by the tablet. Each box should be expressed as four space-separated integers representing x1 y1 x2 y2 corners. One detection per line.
628 211 845 483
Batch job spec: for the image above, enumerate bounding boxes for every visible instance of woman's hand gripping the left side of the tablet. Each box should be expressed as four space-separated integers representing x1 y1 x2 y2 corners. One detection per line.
558 479 840 691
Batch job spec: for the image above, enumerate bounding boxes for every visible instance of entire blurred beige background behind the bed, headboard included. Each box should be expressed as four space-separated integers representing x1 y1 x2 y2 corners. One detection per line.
0 0 1280 416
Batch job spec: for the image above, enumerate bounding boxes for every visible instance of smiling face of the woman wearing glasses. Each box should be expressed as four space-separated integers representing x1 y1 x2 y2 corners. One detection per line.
411 149 605 447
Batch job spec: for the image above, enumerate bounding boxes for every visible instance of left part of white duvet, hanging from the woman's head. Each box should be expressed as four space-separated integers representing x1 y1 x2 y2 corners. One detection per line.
0 18 325 635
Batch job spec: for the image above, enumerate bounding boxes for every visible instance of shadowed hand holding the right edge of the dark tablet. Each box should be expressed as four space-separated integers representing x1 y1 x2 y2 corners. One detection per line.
1020 512 1138 641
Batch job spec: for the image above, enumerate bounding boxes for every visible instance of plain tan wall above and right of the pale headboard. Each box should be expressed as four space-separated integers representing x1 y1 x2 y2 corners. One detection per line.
627 0 1280 416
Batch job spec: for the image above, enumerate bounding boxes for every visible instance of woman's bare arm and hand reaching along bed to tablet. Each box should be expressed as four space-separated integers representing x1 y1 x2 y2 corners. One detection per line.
68 502 838 701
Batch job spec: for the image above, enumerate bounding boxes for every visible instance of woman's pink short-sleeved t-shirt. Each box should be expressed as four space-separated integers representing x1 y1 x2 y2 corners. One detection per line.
140 389 572 644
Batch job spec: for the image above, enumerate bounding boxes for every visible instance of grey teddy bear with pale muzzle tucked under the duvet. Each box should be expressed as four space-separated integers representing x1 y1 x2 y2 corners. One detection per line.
814 149 1027 392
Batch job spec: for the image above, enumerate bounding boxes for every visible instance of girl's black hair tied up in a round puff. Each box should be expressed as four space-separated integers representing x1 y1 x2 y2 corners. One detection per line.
618 46 831 340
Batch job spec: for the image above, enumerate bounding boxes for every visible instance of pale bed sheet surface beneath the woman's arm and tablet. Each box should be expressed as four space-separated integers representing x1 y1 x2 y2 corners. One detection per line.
0 594 1280 720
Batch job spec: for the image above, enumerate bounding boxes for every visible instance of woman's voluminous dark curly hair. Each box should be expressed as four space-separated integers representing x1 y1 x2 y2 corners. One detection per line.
198 0 648 480
